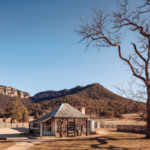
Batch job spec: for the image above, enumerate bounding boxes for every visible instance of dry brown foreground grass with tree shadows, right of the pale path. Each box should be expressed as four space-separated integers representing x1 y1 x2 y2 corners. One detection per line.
28 129 150 150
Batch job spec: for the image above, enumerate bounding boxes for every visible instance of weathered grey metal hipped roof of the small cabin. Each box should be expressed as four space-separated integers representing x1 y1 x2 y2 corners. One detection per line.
30 103 88 123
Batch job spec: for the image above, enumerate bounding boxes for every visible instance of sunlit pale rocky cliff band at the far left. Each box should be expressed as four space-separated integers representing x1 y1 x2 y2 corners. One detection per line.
0 85 30 98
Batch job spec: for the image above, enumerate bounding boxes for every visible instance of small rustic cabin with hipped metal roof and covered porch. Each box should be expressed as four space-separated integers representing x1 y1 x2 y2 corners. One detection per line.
29 103 89 137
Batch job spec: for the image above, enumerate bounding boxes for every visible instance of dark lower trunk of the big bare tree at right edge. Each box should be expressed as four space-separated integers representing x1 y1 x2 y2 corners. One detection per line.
146 86 150 138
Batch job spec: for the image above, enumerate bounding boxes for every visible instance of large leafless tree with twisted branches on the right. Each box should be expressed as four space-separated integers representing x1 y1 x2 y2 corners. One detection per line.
75 0 150 138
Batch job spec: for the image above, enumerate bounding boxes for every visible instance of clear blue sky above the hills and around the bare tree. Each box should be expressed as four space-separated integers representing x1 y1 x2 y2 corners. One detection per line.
0 0 143 96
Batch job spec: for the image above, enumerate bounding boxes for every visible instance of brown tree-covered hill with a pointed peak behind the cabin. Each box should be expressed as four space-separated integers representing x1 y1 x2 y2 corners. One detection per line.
0 83 146 116
